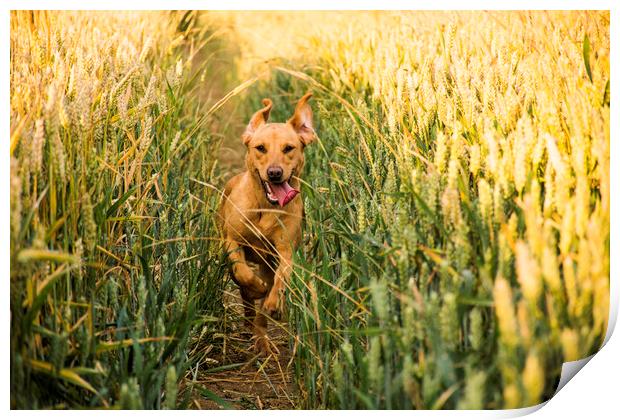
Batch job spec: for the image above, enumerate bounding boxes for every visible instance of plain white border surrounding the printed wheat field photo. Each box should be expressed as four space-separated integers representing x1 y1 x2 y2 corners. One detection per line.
0 0 620 420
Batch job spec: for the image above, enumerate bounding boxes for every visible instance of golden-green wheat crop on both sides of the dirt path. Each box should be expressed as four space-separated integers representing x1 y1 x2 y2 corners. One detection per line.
10 11 610 409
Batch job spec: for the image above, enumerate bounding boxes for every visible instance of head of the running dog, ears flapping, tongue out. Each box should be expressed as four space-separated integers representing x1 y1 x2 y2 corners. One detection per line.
242 93 315 207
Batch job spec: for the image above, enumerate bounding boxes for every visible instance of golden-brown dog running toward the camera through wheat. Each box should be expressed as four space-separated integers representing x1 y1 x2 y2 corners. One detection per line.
219 93 315 354
